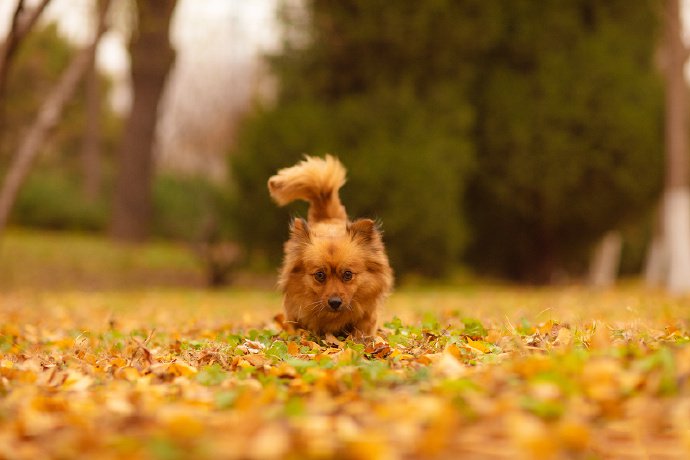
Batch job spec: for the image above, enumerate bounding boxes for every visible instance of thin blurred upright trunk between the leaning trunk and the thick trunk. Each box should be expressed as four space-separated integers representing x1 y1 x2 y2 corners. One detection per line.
81 54 102 201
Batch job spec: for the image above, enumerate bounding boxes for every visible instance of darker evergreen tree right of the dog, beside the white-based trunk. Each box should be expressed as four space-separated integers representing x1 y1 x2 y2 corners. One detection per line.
468 0 663 282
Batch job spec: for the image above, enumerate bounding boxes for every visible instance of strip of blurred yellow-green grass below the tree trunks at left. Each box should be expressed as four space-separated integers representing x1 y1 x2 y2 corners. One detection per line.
0 229 203 289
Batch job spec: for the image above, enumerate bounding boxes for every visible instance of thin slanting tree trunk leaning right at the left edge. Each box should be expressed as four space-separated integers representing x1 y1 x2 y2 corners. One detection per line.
0 0 110 234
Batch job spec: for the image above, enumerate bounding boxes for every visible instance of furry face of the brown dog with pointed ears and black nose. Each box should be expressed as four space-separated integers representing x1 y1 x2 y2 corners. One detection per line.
280 219 392 332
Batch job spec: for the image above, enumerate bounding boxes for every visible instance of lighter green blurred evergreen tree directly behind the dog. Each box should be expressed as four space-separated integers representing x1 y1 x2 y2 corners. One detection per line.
232 0 497 275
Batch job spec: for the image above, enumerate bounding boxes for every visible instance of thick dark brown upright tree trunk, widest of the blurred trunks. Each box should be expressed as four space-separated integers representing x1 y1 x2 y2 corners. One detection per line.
111 0 176 242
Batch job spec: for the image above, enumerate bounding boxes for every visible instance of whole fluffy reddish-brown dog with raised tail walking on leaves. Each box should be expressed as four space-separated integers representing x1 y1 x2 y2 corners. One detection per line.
268 155 393 337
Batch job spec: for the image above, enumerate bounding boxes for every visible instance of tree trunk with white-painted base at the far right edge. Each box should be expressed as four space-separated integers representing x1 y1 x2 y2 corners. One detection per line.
662 0 690 294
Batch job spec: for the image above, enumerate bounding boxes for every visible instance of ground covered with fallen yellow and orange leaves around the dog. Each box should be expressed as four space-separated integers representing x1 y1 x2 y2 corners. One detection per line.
0 287 690 459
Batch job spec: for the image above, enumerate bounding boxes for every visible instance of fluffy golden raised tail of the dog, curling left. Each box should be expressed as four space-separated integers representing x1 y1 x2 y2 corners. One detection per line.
268 155 347 223
